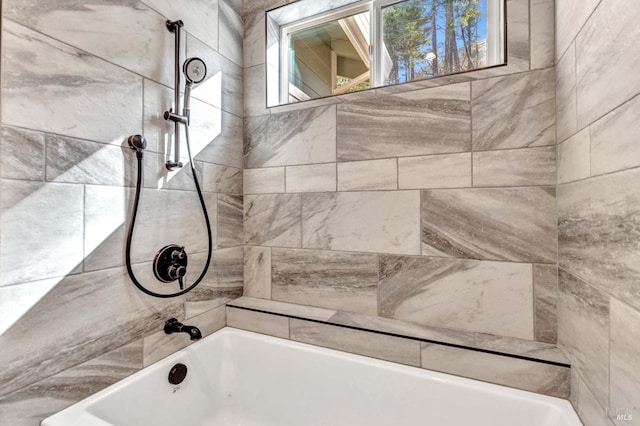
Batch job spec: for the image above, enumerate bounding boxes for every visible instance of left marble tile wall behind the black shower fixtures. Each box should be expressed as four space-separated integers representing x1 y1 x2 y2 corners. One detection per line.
0 0 243 426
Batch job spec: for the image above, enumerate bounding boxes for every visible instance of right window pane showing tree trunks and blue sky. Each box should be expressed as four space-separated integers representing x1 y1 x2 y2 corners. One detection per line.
382 0 492 85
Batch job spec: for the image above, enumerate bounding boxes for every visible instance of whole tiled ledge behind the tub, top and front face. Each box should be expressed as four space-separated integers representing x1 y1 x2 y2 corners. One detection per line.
227 297 571 399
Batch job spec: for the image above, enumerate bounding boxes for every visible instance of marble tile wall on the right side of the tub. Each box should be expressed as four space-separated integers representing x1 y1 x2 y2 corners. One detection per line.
556 0 640 426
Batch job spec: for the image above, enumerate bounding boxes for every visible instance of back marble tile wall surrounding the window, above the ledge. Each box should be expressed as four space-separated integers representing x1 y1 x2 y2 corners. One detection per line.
243 0 558 356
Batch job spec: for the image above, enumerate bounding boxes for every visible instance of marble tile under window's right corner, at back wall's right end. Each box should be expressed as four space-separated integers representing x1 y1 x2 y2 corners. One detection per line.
471 69 556 151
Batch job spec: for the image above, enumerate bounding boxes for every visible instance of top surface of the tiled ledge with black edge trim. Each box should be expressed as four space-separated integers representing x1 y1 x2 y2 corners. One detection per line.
227 296 570 368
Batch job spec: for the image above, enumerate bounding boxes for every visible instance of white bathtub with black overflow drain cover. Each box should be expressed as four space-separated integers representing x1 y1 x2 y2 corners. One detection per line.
42 328 581 426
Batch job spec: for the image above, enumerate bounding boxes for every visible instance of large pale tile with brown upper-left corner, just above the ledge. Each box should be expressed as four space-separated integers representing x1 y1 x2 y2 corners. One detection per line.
378 256 534 340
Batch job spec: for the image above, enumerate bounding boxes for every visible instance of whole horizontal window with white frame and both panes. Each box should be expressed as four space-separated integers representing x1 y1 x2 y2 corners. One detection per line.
267 0 504 106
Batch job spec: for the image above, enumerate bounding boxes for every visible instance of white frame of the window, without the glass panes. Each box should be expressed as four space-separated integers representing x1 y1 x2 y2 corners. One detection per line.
267 0 507 107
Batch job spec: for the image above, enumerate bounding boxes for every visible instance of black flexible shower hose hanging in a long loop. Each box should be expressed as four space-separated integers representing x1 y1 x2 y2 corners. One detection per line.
125 125 212 298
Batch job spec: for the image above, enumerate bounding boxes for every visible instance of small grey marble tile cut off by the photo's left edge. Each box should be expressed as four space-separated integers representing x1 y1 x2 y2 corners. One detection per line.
0 126 45 181
